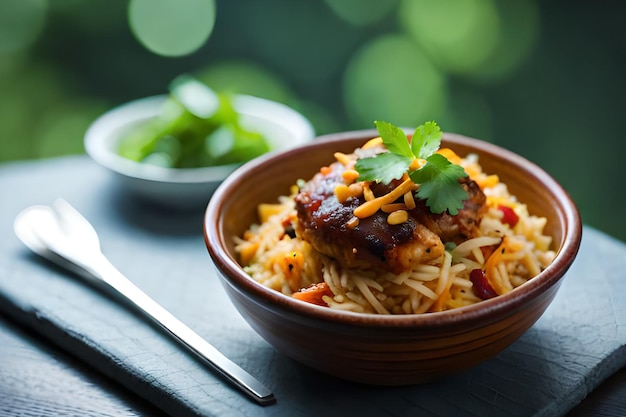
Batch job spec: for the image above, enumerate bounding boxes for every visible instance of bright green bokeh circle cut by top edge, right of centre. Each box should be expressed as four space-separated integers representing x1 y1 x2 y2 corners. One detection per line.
399 0 501 74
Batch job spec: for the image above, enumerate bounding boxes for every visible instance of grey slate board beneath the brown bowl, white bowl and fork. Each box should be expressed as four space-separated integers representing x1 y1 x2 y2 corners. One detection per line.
0 157 626 417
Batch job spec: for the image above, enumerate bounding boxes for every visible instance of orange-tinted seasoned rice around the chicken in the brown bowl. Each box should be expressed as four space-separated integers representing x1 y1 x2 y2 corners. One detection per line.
236 151 555 314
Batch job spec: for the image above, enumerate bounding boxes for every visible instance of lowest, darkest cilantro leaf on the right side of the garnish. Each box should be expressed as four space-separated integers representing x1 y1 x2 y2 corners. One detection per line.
409 154 468 216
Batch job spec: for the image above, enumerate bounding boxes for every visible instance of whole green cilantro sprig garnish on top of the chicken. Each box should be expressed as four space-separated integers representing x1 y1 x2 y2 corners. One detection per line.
355 121 468 216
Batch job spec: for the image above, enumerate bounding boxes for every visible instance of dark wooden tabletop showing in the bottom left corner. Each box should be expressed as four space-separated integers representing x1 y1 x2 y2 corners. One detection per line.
0 314 166 417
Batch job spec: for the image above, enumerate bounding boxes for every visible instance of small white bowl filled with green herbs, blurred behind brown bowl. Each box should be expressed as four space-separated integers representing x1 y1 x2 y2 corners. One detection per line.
85 76 315 210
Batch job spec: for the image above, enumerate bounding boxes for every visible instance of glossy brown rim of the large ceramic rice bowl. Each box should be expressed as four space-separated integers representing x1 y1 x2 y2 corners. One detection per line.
203 129 582 328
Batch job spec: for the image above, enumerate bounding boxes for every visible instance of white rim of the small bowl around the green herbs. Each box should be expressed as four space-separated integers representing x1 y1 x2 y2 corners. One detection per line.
83 94 315 183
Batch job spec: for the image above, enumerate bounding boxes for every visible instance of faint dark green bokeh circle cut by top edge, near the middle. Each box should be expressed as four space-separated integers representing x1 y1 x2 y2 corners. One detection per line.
326 0 398 26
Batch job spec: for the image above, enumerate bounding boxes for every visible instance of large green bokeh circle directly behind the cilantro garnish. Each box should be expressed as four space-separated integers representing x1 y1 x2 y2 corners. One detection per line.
344 35 446 128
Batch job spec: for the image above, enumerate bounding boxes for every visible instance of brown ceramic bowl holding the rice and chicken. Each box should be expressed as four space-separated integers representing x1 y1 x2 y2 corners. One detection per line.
204 130 582 385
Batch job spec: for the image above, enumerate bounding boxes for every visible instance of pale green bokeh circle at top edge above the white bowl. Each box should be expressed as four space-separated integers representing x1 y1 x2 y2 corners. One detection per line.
128 0 215 56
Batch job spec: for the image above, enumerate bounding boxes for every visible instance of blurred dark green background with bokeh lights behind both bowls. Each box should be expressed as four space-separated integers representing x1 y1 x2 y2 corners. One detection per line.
0 0 626 240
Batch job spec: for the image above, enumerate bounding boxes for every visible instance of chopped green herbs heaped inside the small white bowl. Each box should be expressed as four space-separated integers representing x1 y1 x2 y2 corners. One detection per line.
118 75 271 168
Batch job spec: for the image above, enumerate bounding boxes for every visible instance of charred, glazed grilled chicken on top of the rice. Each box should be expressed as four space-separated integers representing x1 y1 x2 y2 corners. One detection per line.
295 154 485 273
